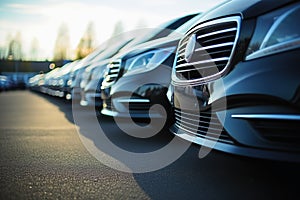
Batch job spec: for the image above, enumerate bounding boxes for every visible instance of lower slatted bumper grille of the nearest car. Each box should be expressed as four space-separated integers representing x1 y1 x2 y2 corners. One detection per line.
175 109 234 144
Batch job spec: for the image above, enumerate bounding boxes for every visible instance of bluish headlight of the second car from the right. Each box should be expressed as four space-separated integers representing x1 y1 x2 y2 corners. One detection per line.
124 47 176 76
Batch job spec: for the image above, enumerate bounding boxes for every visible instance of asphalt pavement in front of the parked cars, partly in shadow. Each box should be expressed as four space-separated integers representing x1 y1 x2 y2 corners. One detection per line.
0 90 300 199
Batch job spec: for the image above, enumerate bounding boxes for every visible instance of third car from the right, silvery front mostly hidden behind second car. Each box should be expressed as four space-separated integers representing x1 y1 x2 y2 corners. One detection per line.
80 14 197 110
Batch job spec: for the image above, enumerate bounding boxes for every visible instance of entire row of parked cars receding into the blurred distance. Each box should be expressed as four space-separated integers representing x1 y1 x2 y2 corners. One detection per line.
30 0 300 162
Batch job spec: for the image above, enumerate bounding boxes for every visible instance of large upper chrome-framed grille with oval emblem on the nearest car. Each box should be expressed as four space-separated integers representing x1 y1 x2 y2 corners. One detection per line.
172 17 240 82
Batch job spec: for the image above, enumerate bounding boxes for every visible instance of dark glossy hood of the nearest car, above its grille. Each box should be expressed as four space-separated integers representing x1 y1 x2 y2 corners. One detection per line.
201 0 296 22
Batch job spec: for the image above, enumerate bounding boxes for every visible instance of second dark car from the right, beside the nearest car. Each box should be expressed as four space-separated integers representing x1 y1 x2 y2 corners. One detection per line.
101 14 201 118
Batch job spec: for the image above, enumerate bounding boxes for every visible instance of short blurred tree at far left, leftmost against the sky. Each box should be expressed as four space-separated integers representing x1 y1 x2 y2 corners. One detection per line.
7 32 22 60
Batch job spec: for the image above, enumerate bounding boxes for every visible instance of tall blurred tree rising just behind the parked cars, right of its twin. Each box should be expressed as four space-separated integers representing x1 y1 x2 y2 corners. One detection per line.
76 22 95 59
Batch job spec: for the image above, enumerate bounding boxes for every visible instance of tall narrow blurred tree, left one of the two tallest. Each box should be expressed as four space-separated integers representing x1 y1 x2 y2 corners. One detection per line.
53 23 70 61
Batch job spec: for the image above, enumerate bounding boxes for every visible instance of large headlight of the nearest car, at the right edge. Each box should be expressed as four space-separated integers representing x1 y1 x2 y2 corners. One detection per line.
246 4 300 60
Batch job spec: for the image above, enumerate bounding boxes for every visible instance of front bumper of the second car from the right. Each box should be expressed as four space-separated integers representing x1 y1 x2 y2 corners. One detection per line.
101 66 171 118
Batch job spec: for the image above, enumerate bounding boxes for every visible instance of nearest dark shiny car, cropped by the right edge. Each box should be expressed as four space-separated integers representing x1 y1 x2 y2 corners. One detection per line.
168 0 300 161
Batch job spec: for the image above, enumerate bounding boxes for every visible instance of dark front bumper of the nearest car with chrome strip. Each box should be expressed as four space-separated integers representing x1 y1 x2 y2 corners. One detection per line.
171 50 300 162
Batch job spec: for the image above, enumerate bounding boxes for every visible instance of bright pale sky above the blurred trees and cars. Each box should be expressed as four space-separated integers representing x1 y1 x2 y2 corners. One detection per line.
0 0 224 60
